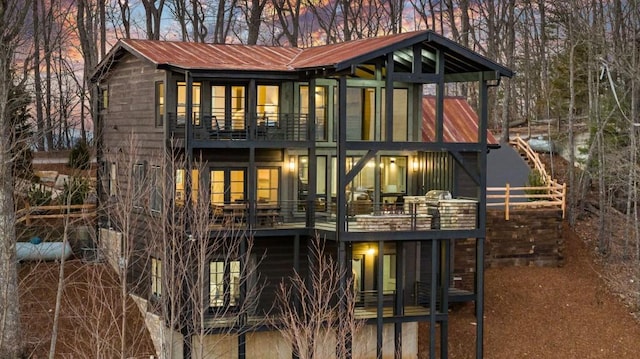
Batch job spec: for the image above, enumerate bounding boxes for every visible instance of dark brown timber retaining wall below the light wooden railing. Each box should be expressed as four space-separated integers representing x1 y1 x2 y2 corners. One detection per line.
485 209 564 267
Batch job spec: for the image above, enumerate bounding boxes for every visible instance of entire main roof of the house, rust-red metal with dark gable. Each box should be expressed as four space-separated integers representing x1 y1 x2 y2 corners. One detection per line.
96 30 513 77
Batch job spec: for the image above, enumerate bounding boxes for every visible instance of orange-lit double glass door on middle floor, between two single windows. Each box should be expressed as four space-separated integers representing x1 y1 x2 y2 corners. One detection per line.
209 169 245 205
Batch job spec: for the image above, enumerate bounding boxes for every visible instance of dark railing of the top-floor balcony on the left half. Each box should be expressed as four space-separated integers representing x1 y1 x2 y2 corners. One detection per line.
168 113 310 141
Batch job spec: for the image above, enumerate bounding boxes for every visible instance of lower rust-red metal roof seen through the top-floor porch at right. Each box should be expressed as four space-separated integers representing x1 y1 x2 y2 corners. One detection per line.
422 96 498 145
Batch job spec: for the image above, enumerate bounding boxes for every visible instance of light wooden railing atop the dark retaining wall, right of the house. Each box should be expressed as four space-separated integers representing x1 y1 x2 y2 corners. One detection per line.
487 136 567 220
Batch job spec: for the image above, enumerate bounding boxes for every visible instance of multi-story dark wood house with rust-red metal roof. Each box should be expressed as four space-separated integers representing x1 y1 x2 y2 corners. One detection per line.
94 31 513 358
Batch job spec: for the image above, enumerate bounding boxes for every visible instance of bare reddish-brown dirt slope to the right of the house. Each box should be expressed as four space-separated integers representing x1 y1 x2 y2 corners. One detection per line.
440 224 640 359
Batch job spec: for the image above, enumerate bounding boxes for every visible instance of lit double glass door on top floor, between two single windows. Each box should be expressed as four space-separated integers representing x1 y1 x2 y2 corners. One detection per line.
210 85 246 130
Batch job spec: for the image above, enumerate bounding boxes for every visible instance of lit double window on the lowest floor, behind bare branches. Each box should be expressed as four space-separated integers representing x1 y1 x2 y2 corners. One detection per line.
209 261 240 308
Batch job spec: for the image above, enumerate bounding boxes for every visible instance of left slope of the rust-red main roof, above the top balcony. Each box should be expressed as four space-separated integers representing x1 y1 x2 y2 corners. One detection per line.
121 39 302 71
